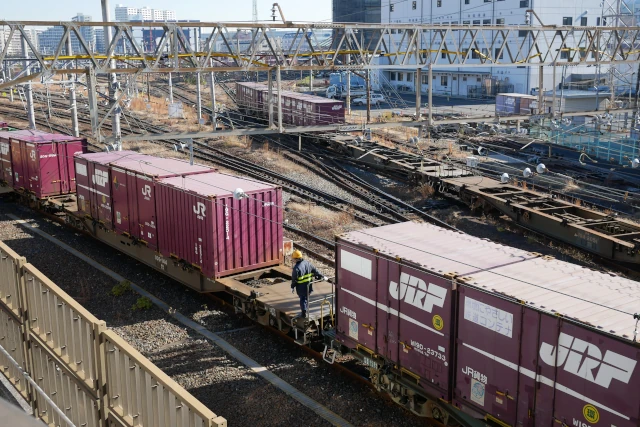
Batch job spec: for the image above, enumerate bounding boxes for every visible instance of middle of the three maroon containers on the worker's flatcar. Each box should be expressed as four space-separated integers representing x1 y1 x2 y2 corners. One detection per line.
109 156 213 249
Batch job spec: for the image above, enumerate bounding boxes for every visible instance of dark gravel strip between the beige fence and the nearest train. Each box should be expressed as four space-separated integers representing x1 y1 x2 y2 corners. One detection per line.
0 200 424 426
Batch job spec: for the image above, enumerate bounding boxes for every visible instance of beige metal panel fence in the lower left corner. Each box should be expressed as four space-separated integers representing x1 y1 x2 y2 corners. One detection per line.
0 242 227 427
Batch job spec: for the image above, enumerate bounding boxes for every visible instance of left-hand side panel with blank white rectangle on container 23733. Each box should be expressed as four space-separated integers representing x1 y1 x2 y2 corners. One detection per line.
337 244 386 352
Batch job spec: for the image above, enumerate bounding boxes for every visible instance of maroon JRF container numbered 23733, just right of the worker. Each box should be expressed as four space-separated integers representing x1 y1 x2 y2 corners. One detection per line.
336 223 532 399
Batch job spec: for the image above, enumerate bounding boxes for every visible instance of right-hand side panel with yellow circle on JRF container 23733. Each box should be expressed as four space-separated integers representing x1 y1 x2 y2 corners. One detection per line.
396 265 453 398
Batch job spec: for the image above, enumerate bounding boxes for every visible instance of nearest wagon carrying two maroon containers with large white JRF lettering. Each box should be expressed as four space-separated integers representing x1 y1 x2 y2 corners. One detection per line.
336 223 640 427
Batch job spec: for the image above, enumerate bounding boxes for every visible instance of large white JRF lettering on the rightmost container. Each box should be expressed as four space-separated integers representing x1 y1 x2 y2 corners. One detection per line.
540 333 637 388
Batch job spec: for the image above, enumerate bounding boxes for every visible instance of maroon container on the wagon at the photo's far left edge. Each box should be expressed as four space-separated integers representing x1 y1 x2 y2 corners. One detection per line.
9 130 87 199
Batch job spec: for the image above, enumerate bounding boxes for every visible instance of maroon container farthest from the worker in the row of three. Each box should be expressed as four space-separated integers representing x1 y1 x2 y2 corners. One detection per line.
75 151 148 230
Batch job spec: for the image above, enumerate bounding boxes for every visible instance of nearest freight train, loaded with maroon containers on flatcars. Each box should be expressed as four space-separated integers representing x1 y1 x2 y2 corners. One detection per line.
0 132 640 427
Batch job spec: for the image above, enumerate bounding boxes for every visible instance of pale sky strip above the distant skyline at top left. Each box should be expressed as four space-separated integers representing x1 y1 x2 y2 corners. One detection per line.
0 0 330 22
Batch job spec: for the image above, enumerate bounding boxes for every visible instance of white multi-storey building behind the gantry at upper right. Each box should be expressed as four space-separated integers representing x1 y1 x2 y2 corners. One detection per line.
382 0 606 96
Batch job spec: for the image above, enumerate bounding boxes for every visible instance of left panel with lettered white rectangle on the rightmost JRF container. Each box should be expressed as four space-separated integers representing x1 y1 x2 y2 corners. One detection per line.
455 286 522 425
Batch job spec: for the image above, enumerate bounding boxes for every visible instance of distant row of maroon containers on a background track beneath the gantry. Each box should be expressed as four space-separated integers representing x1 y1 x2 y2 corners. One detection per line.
236 82 344 126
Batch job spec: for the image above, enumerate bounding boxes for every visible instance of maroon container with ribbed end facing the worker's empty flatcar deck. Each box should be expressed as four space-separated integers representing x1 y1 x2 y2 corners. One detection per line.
156 173 283 278
